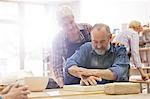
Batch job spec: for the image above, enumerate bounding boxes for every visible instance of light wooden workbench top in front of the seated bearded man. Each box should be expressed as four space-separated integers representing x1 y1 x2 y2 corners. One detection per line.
29 85 150 99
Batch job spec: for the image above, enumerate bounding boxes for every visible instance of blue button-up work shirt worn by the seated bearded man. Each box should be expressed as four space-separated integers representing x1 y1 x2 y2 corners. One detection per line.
64 42 130 84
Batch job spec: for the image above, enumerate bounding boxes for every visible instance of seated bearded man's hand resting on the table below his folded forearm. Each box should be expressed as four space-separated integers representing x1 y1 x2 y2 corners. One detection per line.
80 76 102 86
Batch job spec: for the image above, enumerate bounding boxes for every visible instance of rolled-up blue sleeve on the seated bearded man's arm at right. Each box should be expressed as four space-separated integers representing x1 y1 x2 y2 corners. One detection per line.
109 46 130 81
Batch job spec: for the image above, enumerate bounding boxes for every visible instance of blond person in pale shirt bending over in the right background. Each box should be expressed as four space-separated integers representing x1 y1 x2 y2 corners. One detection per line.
113 20 149 80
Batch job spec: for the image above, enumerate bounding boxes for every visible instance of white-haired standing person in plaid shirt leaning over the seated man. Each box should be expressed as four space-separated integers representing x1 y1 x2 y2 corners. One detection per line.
52 6 92 87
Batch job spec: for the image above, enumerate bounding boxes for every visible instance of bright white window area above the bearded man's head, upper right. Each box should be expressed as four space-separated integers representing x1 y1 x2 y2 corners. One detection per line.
80 0 150 28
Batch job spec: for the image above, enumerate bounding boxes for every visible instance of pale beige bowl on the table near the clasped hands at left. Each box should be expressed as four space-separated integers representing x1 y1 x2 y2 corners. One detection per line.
24 77 49 91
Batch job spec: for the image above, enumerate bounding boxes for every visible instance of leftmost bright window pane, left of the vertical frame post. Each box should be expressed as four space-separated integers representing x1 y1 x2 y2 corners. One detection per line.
0 2 20 73
